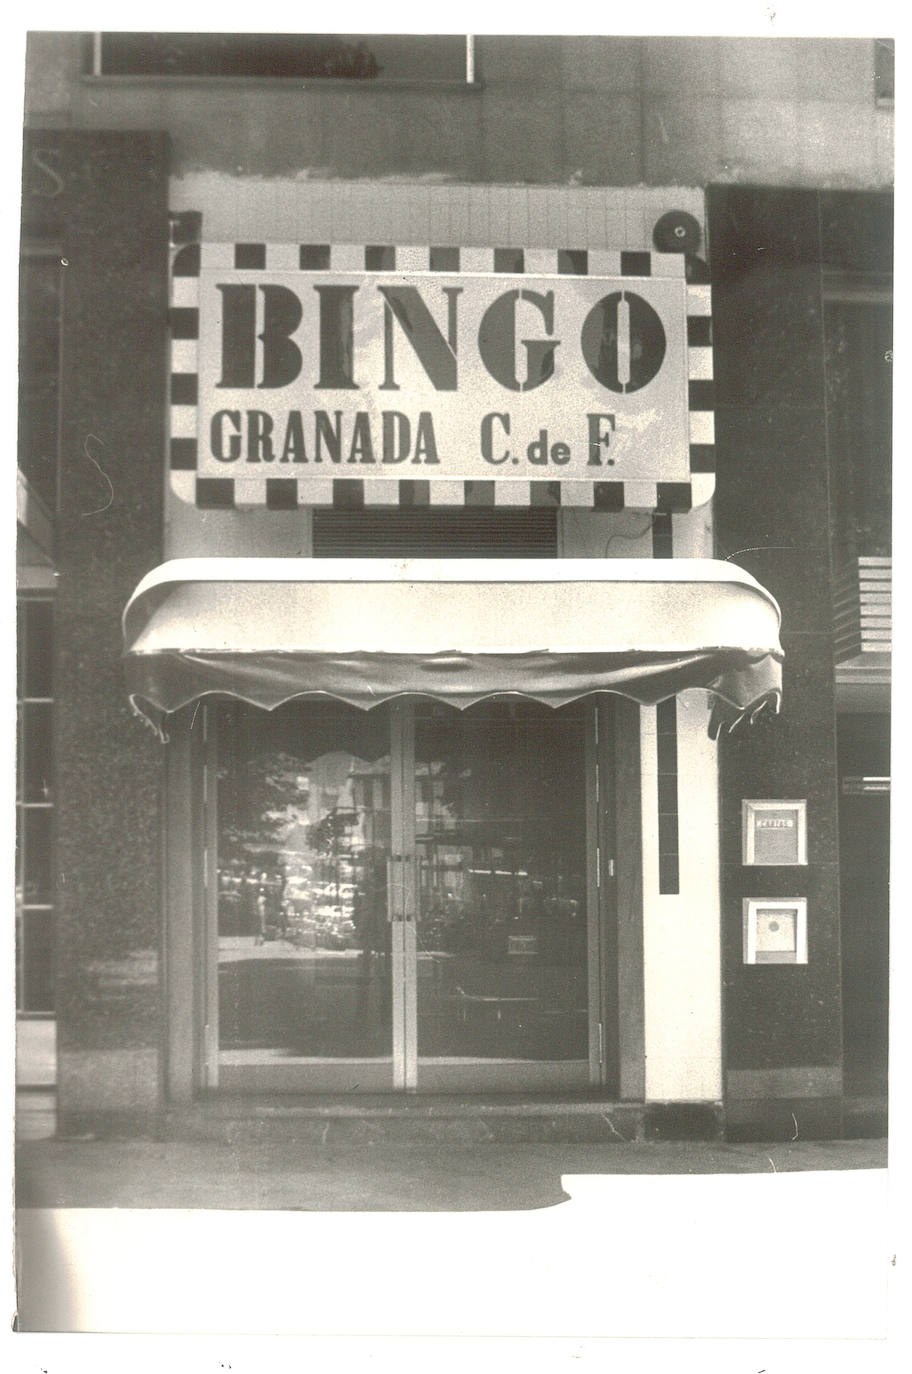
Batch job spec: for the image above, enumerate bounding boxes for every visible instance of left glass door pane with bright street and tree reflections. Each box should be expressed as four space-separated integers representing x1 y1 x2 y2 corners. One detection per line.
216 701 393 1091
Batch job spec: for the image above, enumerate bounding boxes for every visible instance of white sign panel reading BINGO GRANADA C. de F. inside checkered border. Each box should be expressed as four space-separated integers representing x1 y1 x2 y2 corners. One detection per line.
172 245 711 507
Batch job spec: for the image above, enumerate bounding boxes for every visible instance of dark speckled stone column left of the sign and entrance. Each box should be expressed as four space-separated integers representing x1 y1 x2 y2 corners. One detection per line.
32 132 168 1134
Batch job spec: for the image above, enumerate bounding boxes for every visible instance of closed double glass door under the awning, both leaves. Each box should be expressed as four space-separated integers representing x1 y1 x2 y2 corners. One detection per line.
209 698 602 1092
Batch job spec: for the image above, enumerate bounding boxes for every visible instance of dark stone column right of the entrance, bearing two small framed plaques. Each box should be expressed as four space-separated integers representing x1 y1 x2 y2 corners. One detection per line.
709 187 842 1138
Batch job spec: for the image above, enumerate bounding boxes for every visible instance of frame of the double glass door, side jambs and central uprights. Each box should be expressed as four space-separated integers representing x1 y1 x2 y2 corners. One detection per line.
185 694 626 1101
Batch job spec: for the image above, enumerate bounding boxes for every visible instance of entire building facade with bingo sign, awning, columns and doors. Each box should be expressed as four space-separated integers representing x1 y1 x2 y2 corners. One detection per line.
18 34 893 1139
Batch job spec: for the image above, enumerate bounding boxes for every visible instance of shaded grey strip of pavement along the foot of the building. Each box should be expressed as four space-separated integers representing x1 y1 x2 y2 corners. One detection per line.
15 1094 887 1212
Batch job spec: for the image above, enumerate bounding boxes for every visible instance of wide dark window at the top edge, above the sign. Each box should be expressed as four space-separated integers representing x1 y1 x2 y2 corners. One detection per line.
91 33 472 82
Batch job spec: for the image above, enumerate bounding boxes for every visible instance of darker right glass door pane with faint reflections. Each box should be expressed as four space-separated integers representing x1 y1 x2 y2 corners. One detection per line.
415 699 589 1090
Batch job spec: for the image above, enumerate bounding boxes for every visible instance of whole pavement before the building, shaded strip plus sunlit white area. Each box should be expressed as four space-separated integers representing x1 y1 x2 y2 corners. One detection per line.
15 1091 897 1341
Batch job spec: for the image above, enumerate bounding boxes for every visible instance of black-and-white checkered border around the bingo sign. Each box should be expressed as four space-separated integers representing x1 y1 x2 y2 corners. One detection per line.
169 242 716 511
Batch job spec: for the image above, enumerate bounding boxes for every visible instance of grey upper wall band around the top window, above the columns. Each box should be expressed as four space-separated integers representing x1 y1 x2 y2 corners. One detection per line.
26 33 893 187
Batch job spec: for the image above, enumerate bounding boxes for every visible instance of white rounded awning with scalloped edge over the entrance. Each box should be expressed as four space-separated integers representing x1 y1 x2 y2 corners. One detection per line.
124 558 782 728
